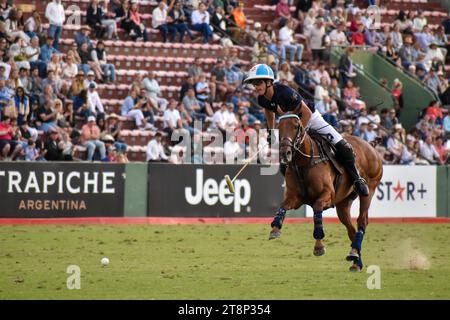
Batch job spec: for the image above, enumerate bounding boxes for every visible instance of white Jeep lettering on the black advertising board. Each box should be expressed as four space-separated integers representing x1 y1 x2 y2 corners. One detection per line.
184 169 252 213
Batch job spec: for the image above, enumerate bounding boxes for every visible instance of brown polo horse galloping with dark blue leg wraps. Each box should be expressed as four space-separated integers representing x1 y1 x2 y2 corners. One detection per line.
269 110 383 271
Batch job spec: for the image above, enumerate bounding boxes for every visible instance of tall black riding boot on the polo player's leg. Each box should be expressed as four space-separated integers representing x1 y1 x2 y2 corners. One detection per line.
335 140 369 196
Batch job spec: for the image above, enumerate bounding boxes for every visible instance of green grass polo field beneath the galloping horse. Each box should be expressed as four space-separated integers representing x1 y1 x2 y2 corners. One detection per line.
0 223 450 299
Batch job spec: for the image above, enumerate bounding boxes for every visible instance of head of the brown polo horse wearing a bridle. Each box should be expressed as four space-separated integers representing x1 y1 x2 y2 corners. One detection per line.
278 107 305 164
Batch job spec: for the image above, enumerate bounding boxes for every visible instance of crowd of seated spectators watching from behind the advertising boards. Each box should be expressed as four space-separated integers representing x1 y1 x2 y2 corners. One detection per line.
0 0 450 164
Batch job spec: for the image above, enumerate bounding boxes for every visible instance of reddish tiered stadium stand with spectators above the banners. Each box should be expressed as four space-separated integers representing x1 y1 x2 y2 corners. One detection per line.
0 0 450 164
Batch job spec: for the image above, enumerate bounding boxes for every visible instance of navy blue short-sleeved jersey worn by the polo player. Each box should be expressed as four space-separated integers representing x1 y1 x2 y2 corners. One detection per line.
258 82 315 113
